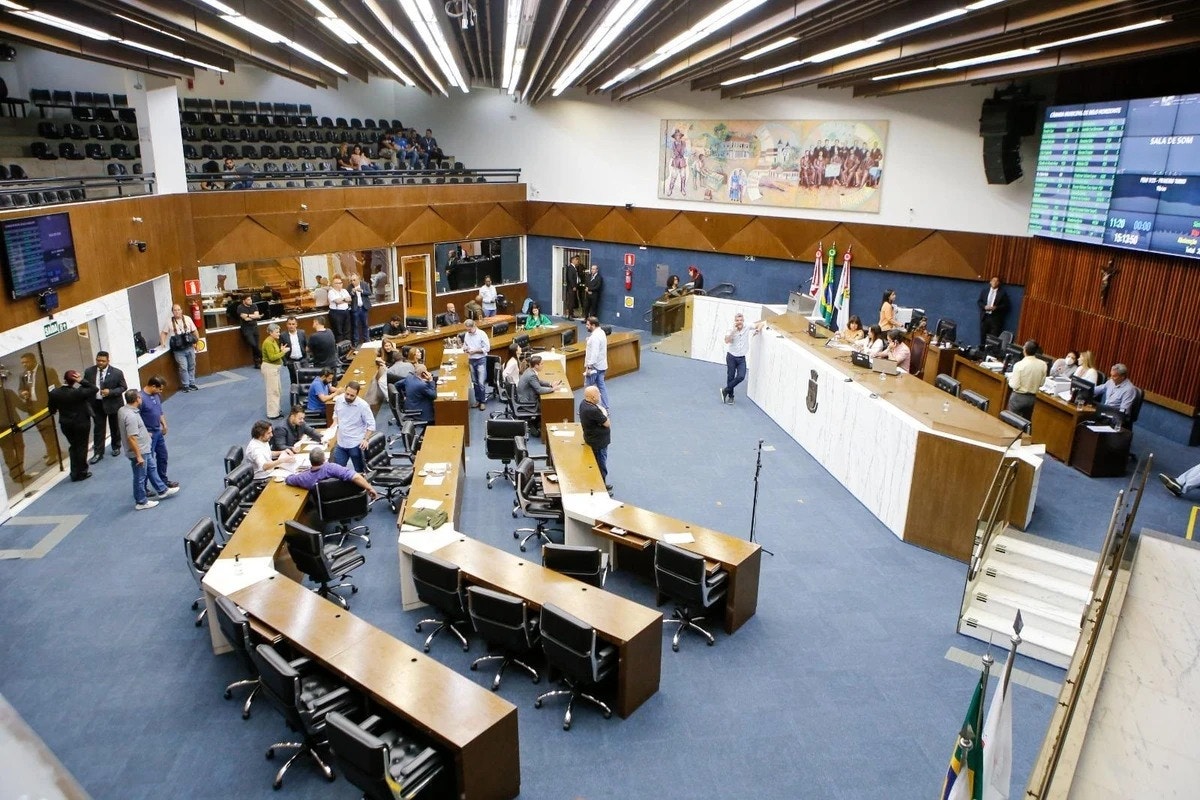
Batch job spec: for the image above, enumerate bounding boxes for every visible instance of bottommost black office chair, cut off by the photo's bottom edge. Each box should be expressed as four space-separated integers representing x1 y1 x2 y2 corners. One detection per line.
325 711 445 800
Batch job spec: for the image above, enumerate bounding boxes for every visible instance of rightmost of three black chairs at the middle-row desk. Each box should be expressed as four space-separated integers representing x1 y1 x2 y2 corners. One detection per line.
534 603 618 730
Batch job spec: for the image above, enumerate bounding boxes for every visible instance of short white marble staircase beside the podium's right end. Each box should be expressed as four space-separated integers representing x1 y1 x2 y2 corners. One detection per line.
959 531 1096 668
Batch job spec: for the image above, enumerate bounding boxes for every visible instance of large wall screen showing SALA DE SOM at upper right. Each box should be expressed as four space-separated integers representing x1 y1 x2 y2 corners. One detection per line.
1028 95 1200 258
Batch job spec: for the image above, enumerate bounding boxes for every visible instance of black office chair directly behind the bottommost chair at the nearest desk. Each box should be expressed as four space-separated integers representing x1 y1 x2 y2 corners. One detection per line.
250 644 355 789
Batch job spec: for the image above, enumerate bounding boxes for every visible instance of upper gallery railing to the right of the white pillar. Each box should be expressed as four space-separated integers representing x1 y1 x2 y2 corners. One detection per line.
187 168 521 191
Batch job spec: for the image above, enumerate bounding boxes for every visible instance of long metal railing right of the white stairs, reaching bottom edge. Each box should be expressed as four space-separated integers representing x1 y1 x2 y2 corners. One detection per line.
1025 453 1154 800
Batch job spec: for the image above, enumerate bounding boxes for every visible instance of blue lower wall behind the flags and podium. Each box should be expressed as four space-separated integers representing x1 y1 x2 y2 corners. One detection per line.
526 236 1025 342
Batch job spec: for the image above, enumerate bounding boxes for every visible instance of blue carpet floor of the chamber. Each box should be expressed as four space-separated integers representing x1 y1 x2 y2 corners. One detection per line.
0 328 1196 800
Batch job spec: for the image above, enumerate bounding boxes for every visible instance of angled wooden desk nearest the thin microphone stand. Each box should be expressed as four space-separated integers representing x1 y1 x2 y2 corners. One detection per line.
546 423 762 633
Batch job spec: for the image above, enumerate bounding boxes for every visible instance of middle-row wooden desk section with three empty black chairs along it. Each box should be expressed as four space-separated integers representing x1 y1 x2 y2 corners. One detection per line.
436 537 662 717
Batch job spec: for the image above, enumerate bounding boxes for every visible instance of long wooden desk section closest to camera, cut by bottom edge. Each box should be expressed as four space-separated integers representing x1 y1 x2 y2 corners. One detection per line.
230 576 521 800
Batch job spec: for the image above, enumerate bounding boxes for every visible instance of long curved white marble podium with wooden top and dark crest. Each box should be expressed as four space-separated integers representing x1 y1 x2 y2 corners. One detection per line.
692 297 1043 561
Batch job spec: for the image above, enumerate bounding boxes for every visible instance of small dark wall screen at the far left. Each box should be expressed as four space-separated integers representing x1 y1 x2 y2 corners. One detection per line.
0 213 79 300
